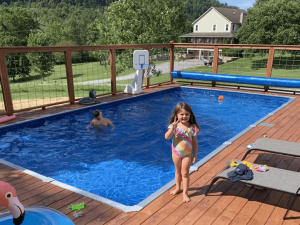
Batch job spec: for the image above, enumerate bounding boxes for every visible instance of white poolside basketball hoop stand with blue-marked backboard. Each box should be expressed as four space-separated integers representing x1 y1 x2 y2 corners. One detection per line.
124 50 149 94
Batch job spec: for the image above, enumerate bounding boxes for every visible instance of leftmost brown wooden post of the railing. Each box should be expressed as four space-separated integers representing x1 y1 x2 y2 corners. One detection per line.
0 52 14 116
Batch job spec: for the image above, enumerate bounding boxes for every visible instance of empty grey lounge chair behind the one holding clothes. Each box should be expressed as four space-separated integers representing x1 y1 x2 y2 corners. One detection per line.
242 138 300 160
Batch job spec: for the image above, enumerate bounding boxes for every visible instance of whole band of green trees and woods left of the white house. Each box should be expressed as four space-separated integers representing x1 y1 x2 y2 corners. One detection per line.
0 0 237 80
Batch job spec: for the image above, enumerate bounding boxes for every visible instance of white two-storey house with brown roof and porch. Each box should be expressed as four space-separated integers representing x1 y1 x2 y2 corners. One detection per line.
180 7 247 55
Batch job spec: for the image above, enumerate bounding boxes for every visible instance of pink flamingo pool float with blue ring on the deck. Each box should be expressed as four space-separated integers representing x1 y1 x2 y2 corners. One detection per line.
0 181 74 225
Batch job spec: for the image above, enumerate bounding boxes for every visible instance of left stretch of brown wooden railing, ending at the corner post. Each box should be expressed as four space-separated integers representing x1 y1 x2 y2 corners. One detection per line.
0 43 174 116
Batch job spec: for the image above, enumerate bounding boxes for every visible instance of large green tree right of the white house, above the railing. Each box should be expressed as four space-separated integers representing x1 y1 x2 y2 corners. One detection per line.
237 0 300 45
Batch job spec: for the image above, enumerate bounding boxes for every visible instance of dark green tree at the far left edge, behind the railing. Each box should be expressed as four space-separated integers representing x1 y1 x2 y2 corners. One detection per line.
0 7 39 81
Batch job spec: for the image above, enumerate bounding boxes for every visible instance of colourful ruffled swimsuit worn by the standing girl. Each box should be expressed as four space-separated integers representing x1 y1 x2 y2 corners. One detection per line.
168 124 199 158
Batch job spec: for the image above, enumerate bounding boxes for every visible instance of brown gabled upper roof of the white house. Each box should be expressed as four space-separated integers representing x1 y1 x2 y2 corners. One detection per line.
193 7 247 24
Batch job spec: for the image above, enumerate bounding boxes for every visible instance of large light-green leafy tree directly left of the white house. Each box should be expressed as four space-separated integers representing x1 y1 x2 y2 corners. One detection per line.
97 0 190 44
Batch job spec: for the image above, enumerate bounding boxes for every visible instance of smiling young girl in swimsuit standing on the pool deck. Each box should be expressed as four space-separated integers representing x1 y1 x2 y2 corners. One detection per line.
165 103 200 202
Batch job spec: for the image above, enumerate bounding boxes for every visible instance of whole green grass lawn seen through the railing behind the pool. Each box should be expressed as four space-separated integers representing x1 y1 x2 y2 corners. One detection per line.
0 54 300 102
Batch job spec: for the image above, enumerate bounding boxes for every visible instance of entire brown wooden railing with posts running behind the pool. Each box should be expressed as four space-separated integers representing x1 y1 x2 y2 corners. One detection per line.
0 41 300 115
